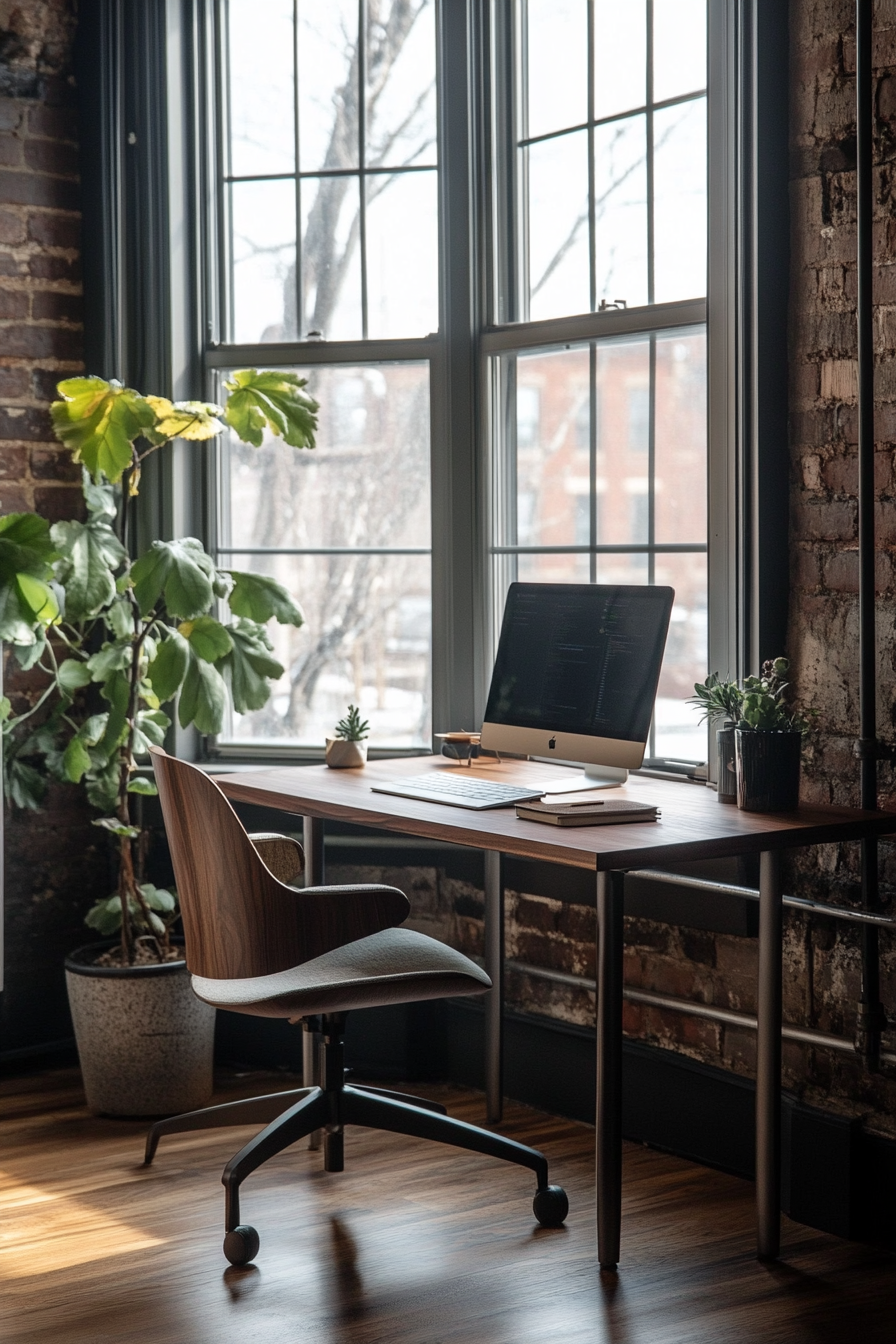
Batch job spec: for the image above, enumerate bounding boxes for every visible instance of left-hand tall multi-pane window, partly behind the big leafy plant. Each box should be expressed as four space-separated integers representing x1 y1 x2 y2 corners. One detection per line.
209 0 439 750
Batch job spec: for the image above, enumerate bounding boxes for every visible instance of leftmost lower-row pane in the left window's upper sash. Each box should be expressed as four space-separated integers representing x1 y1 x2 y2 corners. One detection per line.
230 180 296 343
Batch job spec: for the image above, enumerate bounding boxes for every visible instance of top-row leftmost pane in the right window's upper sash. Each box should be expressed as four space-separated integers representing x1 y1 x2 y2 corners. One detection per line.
524 0 588 136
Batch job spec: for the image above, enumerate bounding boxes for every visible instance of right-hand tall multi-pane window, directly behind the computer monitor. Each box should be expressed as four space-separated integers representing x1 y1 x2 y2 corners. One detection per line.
484 0 708 761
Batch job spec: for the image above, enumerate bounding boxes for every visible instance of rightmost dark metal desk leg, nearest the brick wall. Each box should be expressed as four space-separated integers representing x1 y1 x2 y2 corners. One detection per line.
756 852 783 1259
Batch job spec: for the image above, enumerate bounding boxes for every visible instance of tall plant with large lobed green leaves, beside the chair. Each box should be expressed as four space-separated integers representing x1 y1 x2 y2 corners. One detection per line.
0 370 318 964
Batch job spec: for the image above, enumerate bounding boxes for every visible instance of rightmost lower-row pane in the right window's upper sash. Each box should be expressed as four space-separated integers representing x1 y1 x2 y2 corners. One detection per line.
653 98 707 304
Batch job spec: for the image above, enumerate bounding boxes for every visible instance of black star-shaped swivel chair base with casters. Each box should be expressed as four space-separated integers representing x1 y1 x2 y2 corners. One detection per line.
146 1013 570 1265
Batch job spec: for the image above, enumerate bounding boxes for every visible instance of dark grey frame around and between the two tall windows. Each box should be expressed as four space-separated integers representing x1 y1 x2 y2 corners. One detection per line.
78 0 789 759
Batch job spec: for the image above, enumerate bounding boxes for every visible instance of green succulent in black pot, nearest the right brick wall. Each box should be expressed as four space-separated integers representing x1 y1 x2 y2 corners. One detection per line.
735 659 807 812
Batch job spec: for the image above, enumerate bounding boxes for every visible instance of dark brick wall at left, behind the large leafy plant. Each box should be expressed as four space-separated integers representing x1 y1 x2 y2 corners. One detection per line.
0 0 106 1051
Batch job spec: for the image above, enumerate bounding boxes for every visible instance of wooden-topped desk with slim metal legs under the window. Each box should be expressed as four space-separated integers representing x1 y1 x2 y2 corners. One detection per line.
218 757 896 1269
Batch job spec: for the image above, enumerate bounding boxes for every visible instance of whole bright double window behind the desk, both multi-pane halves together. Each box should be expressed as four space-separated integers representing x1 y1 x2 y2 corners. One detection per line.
117 0 720 759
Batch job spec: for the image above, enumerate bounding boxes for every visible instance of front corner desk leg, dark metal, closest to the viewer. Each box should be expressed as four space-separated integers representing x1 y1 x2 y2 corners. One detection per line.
595 872 623 1270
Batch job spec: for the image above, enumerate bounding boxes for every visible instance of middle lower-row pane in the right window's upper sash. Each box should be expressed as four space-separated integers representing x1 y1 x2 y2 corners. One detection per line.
594 117 647 308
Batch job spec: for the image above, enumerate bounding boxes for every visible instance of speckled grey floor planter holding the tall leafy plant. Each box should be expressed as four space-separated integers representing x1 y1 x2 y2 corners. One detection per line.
66 943 215 1116
